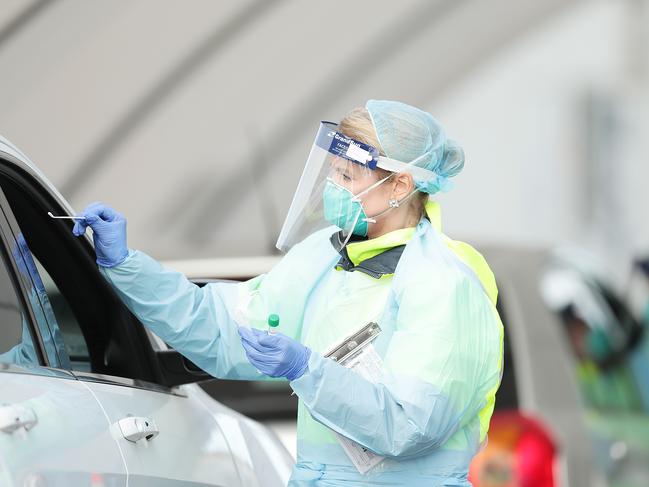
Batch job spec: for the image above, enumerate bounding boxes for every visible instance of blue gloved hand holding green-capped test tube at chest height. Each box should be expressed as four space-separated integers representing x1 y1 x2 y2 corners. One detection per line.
239 327 311 380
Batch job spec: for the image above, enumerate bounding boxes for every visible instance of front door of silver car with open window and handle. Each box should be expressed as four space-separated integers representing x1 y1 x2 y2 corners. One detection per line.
0 155 240 487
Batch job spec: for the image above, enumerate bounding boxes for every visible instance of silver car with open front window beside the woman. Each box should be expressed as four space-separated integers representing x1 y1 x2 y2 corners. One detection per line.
0 139 293 487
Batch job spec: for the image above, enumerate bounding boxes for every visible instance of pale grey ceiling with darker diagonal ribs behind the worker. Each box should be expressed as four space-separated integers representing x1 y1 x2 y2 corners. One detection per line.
0 0 584 258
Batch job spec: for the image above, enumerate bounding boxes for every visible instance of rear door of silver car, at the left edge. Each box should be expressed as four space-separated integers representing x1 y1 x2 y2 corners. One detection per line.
0 193 127 487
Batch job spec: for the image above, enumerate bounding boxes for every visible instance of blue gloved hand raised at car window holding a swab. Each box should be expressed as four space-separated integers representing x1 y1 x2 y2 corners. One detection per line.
72 202 128 267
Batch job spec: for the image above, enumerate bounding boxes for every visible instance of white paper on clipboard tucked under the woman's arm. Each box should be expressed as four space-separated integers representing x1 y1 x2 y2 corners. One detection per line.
325 323 385 474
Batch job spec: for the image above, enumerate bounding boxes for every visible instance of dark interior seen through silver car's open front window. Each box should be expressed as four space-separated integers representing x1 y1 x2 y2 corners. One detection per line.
0 161 209 386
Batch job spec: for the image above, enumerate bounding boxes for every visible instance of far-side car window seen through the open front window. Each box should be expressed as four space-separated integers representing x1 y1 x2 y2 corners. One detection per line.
33 256 91 372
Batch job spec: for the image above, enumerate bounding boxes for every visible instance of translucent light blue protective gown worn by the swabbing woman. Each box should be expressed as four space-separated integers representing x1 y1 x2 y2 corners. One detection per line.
101 212 502 486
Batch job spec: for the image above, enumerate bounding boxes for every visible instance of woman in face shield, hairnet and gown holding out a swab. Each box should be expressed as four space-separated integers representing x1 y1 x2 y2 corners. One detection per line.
74 100 502 486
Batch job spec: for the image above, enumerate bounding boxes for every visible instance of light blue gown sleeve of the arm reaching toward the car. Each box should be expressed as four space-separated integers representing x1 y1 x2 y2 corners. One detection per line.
99 250 284 380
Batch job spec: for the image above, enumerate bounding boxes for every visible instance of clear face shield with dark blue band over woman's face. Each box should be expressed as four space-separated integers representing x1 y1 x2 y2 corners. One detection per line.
277 122 420 252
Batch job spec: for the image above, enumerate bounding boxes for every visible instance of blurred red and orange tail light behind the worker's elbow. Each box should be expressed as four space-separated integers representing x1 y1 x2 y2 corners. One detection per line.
469 411 557 487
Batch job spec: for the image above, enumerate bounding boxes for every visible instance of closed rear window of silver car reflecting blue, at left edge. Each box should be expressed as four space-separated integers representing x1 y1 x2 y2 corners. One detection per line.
0 244 39 365
